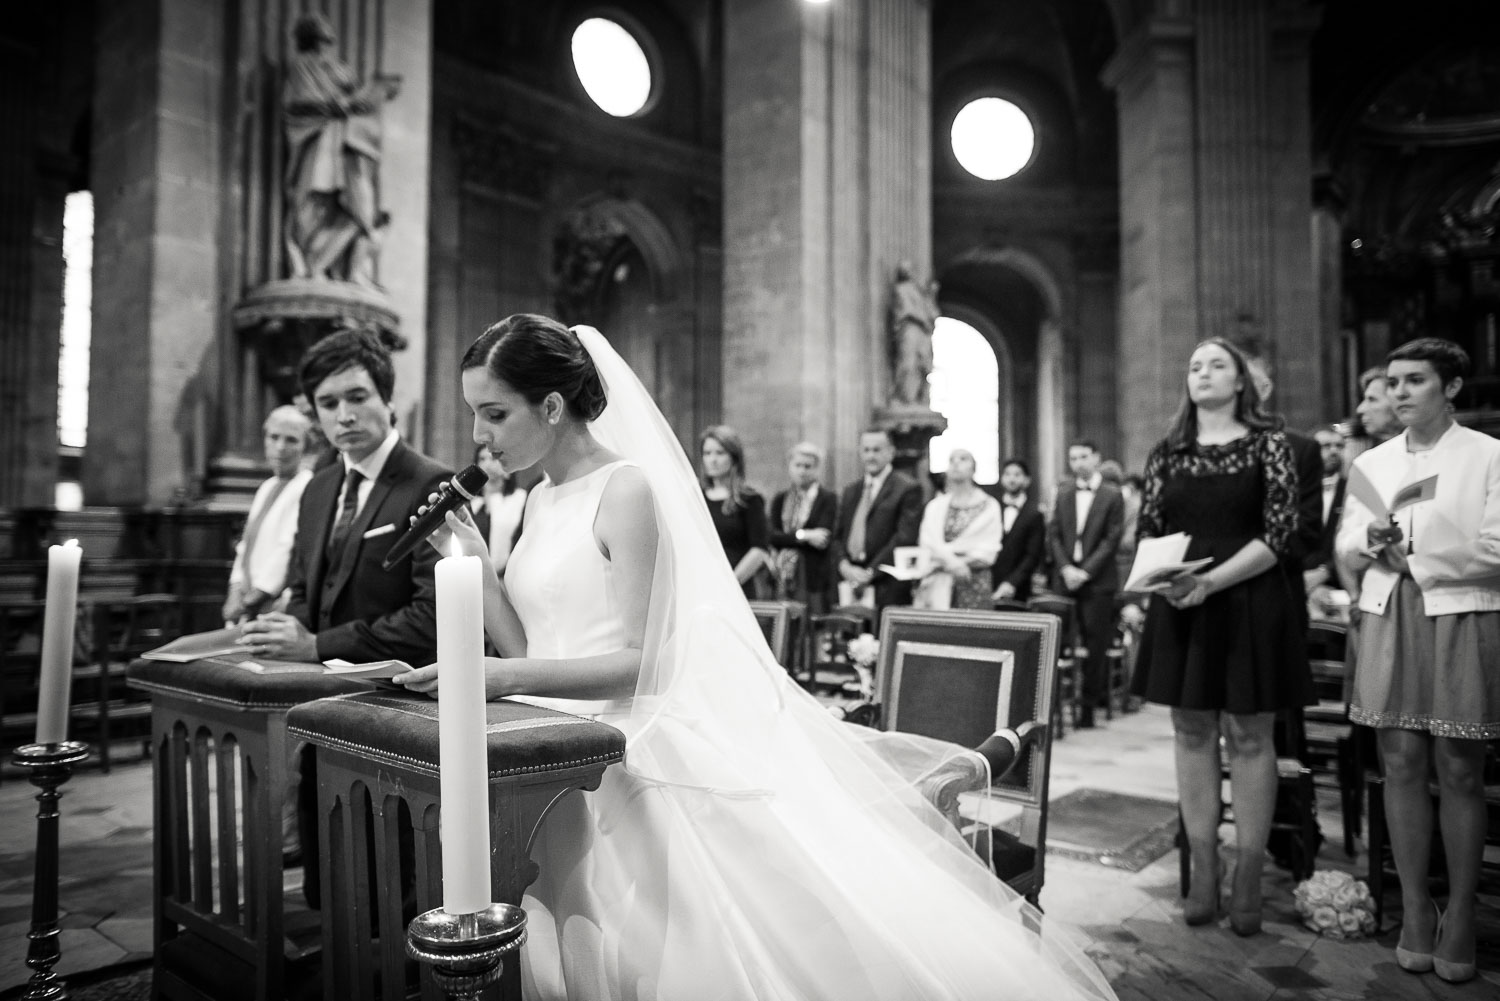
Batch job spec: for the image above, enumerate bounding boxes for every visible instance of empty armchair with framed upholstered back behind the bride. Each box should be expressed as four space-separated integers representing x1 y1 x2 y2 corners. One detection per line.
876 608 1058 903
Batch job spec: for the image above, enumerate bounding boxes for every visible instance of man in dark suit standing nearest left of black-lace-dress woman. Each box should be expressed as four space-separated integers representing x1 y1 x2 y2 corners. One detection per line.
1047 441 1125 726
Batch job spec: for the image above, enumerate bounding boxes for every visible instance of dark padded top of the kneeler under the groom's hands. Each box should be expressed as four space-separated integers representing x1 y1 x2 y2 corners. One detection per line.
126 657 371 711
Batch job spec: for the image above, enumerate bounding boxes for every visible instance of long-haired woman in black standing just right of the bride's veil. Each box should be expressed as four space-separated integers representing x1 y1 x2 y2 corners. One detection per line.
698 425 773 599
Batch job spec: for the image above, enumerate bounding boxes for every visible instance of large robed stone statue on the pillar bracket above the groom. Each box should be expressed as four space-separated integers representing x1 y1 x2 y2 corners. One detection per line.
282 14 401 288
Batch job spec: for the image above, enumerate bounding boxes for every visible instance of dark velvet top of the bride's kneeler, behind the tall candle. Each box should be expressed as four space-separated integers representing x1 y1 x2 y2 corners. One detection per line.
287 692 626 779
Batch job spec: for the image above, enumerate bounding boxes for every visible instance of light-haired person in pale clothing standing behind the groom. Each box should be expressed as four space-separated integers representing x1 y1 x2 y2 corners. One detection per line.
224 405 312 626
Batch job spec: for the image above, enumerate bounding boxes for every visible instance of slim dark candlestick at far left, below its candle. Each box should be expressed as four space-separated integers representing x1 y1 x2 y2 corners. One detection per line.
14 740 89 1001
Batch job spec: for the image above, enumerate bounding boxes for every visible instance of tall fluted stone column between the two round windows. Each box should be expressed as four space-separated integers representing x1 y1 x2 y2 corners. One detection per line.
723 0 932 485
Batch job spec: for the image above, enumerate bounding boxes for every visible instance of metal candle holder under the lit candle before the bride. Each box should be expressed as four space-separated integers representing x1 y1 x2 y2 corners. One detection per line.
407 903 527 1001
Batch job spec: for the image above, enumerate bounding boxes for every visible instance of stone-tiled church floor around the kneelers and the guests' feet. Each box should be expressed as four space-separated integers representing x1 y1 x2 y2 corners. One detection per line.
0 707 1500 1001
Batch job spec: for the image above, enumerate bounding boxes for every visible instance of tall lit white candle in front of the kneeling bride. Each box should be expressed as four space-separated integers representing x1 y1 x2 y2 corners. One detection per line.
437 546 491 914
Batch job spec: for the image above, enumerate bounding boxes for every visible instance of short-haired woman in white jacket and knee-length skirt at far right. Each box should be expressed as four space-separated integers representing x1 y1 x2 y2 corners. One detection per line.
1338 338 1500 983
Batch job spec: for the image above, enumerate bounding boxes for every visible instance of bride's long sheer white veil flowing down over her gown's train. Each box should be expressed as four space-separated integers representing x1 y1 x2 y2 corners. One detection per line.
573 327 1115 1001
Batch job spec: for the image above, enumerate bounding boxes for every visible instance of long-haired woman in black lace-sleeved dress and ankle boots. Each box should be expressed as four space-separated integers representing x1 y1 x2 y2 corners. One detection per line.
1131 338 1313 935
